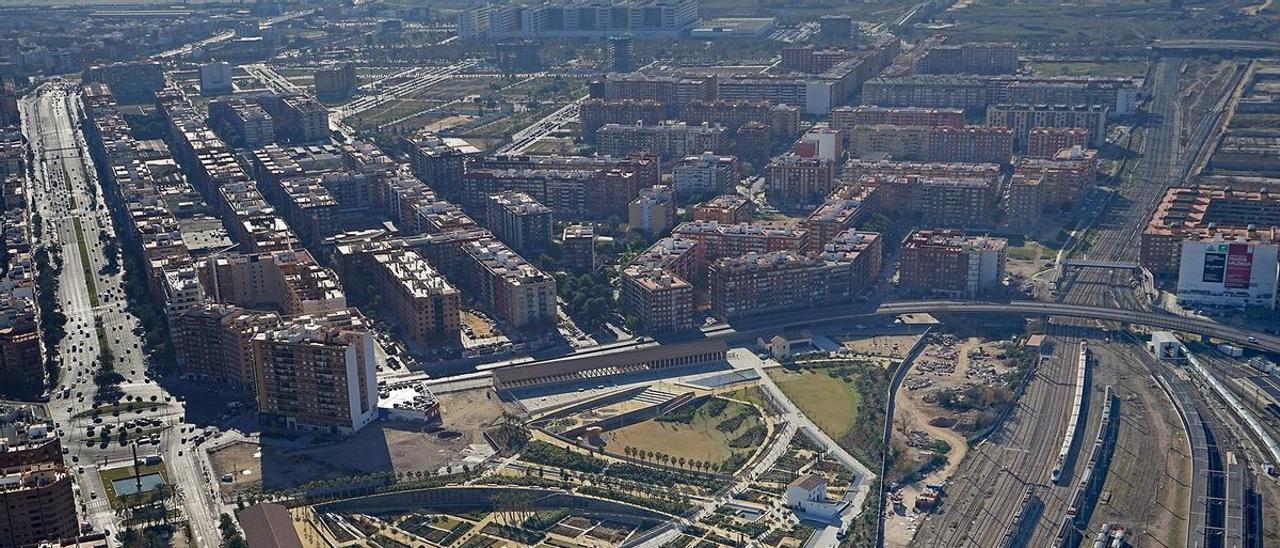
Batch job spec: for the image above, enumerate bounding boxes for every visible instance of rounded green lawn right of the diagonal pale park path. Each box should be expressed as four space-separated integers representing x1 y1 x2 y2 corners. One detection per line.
768 367 861 440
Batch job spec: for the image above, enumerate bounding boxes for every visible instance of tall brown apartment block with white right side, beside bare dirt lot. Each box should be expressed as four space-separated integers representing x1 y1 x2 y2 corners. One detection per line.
253 310 378 435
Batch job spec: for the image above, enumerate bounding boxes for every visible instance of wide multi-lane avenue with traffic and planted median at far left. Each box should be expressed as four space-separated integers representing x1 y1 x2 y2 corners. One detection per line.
22 86 221 545
